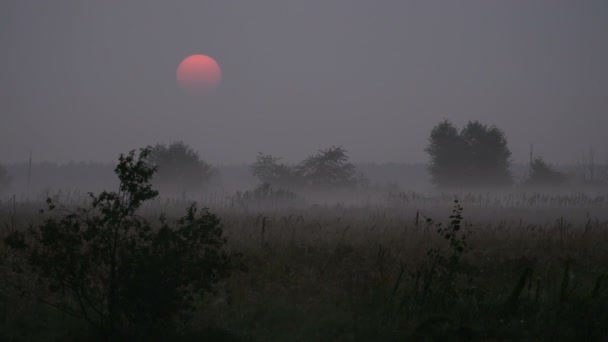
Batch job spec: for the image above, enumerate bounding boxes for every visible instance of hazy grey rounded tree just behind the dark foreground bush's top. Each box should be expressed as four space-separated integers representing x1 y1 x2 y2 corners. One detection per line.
148 141 213 193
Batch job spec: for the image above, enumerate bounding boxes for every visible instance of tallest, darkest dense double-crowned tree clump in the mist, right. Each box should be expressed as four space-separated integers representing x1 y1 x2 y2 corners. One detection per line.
426 120 512 187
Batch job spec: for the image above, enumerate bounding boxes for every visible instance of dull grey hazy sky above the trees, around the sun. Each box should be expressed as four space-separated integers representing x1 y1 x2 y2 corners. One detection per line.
0 0 608 163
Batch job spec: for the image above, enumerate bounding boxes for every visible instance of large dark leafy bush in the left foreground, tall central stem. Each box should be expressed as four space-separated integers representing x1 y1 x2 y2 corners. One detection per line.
5 148 236 339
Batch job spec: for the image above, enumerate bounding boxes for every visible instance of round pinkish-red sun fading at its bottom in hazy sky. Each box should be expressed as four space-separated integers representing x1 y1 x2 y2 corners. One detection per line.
176 55 222 95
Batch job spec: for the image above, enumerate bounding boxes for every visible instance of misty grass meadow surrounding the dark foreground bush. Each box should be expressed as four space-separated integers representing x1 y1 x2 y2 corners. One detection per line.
0 191 608 341
